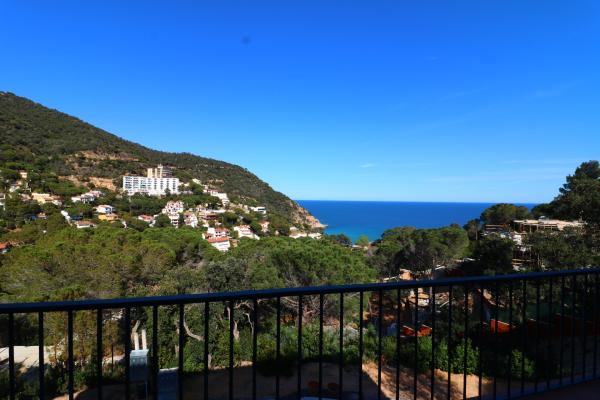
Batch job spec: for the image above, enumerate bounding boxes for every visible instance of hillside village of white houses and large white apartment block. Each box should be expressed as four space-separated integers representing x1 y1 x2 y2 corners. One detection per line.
0 164 322 252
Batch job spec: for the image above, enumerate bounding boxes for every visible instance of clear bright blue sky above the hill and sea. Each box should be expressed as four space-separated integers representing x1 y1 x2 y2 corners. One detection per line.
0 0 600 202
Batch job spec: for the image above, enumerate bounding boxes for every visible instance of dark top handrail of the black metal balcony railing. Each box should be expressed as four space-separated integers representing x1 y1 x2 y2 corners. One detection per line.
0 267 600 314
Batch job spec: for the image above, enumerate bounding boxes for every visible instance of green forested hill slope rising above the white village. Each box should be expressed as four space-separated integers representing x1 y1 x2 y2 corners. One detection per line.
0 92 309 222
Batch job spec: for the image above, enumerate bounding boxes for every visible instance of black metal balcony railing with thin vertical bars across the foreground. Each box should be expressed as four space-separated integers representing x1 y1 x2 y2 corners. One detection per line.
0 269 600 399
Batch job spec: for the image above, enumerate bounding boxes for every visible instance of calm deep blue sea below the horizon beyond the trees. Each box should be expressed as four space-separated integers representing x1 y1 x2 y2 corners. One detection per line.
298 200 535 240
